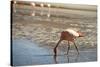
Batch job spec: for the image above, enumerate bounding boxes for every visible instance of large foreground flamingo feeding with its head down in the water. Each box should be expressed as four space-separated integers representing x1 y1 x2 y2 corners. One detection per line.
54 29 84 56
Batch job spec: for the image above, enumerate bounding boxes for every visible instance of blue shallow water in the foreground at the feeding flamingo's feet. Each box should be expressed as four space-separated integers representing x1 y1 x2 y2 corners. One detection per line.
12 39 97 66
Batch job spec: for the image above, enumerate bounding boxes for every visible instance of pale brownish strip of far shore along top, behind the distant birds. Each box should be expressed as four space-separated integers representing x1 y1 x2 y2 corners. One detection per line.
13 1 97 11
